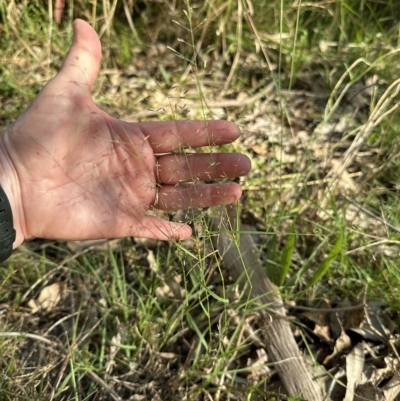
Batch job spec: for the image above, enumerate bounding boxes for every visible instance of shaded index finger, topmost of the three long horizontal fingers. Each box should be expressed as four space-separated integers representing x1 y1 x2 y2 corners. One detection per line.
139 120 240 153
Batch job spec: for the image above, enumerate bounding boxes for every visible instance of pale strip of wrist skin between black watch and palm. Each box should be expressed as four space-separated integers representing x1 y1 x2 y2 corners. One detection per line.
0 127 25 249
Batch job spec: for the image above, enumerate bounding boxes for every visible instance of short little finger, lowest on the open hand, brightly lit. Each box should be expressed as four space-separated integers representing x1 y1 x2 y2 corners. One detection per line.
130 216 192 241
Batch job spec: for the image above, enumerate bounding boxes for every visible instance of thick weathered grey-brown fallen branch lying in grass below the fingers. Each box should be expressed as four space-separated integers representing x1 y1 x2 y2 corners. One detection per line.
212 206 322 401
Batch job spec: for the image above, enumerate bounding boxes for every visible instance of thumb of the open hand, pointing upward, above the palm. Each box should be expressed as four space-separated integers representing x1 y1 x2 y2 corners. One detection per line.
58 19 101 89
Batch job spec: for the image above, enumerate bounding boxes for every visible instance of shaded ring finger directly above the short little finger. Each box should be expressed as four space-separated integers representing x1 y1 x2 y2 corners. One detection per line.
158 182 242 212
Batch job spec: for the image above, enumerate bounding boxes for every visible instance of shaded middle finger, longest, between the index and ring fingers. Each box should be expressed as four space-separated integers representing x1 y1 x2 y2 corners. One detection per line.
156 153 251 185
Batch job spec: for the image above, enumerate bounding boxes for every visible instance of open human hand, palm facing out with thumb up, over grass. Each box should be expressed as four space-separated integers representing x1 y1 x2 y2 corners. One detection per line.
0 20 250 247
